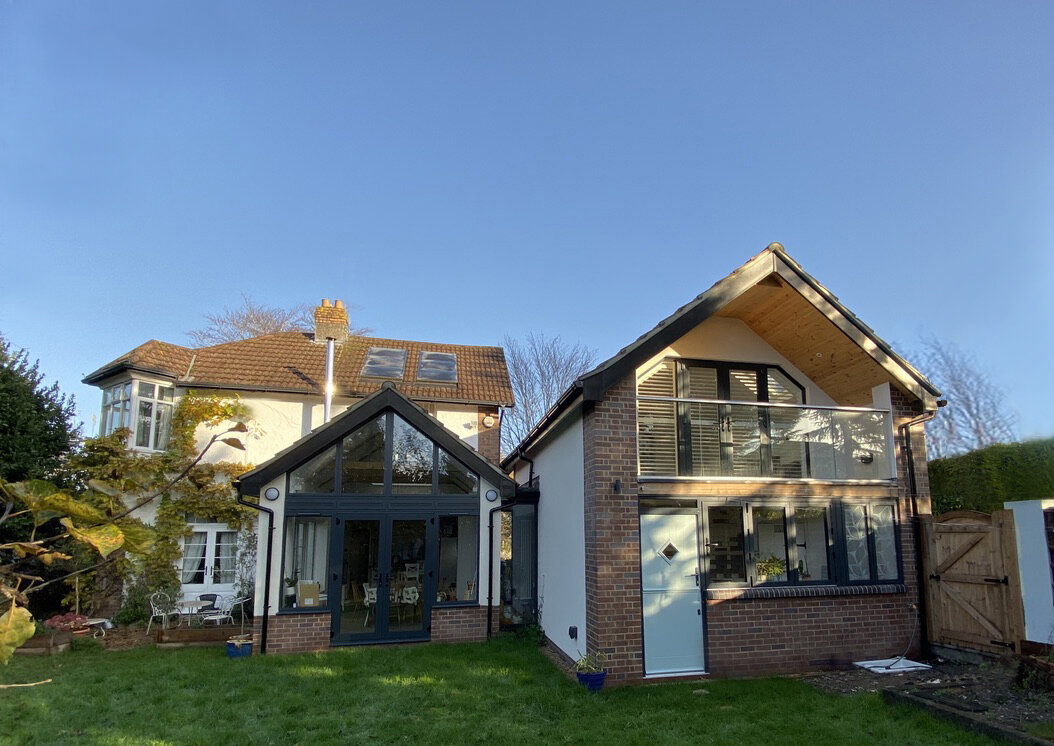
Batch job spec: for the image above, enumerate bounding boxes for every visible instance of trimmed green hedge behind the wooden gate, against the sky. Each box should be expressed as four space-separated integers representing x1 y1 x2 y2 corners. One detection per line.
930 437 1054 514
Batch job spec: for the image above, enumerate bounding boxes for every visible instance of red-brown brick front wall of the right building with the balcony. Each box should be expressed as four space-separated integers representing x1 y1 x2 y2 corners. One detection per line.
583 376 930 685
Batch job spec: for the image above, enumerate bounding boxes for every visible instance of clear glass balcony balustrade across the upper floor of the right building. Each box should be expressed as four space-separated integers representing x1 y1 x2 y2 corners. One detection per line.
637 395 895 482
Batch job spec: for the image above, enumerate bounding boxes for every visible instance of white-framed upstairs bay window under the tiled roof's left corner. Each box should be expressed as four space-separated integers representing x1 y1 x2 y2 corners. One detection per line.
99 380 175 451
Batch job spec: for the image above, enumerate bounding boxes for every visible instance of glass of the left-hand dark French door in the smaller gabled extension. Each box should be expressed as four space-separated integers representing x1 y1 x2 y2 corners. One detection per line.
336 519 388 636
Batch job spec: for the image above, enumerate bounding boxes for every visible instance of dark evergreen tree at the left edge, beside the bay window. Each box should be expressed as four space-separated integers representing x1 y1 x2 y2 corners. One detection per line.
0 336 80 482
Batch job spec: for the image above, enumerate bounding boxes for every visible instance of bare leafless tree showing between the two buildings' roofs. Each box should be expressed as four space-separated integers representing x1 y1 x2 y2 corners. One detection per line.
502 332 597 453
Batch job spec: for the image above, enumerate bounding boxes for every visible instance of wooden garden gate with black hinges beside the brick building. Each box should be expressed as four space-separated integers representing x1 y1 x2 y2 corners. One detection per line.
920 510 1024 654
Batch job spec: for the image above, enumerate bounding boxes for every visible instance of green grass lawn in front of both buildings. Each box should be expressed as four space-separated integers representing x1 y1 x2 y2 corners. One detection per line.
0 640 991 746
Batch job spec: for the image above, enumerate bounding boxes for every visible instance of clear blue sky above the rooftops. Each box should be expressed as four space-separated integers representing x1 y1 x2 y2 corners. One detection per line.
0 0 1054 437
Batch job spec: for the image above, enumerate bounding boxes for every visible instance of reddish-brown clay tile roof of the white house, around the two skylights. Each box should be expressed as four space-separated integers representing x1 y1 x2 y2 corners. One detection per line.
84 332 513 406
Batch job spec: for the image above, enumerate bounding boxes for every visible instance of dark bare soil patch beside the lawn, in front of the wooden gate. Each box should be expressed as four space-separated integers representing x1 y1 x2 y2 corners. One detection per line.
809 660 1054 732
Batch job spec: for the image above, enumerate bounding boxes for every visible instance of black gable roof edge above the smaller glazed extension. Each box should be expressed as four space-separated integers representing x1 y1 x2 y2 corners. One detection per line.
237 384 515 497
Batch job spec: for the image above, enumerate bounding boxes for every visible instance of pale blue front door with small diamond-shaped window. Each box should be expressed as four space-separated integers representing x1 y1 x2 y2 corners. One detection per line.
641 509 706 675
